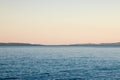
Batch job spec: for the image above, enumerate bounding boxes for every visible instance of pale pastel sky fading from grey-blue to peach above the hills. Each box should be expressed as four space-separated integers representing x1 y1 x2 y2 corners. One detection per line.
0 0 120 44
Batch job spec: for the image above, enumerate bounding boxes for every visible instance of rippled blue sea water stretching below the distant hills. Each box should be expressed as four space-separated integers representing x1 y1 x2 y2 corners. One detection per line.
0 46 120 80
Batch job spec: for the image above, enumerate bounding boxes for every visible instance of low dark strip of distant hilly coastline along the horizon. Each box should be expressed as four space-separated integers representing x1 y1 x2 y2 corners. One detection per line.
0 42 120 47
